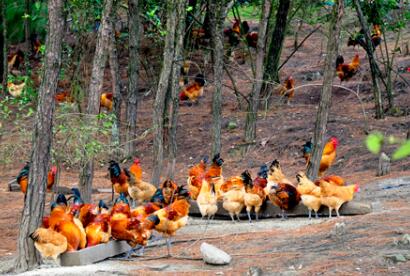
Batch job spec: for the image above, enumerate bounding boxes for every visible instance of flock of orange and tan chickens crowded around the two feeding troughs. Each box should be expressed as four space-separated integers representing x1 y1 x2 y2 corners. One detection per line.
17 137 358 260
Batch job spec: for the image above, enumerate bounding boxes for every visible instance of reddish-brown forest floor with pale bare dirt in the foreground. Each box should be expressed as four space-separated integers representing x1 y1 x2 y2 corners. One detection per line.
0 22 410 275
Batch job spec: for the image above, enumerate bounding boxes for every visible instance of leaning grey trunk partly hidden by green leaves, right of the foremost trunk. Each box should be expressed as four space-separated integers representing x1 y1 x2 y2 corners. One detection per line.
79 0 113 202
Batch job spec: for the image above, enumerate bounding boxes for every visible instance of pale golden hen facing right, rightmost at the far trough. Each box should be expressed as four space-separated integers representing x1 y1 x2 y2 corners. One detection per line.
319 181 360 218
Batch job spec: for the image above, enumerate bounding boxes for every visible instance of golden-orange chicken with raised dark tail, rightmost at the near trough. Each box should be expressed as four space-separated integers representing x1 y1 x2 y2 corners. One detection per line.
146 189 190 256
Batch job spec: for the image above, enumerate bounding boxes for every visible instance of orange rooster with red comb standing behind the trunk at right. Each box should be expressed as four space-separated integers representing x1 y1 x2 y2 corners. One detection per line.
303 137 339 176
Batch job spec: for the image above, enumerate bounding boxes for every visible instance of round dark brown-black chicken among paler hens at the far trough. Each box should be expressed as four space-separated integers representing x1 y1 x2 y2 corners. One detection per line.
268 183 301 219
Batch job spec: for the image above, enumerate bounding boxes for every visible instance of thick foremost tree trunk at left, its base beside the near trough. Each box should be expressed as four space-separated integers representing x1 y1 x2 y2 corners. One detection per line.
15 0 64 271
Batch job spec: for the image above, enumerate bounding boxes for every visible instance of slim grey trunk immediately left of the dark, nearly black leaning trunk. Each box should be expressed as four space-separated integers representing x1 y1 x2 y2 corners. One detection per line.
245 0 272 147
